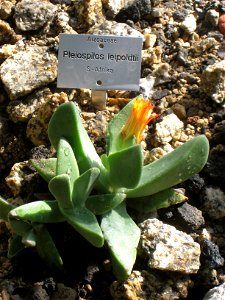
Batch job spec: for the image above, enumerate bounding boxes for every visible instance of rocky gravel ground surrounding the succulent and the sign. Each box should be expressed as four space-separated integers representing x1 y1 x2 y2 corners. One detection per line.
0 0 225 300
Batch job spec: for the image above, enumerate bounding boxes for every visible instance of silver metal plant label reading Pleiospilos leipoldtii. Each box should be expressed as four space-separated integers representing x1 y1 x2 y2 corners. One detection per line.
57 34 142 91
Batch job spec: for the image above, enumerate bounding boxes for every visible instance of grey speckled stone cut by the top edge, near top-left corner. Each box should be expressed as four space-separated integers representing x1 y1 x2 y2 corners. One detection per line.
14 0 57 31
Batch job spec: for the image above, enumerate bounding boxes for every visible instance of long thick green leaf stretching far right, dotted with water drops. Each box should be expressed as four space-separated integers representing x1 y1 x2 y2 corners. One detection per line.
126 135 209 198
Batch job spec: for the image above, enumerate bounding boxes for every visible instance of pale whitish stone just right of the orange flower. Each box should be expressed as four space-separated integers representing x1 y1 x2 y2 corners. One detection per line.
152 113 184 146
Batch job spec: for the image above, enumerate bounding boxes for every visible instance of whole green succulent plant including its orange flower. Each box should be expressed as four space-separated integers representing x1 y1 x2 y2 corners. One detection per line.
0 98 209 280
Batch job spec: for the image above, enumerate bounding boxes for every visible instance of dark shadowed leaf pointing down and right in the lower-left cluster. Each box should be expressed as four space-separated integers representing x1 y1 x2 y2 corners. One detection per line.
34 224 63 270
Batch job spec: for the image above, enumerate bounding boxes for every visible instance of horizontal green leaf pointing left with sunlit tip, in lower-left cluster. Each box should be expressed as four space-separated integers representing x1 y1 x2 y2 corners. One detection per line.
9 201 65 223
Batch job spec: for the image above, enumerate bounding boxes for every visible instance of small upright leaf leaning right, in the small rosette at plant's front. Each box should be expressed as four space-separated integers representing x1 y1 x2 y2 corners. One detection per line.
72 168 100 207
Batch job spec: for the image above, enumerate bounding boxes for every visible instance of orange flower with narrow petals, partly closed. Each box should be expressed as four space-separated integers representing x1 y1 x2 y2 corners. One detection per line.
121 98 159 143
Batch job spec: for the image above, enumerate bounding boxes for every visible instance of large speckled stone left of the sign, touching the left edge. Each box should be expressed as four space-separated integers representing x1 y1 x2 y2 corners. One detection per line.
0 45 57 100
